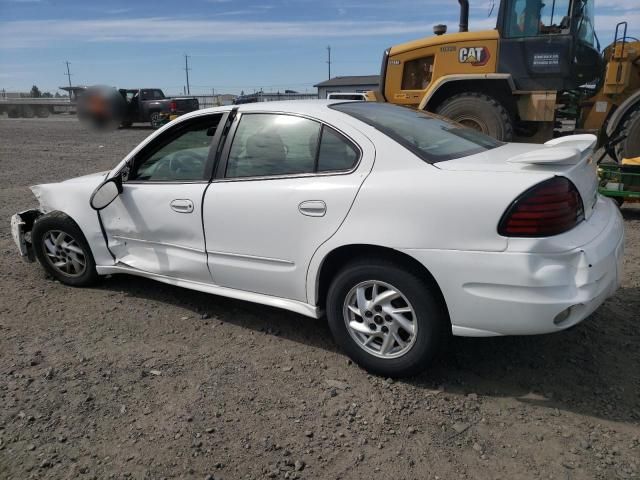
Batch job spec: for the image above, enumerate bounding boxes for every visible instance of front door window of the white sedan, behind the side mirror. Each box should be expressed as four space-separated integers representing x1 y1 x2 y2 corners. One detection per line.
128 115 222 182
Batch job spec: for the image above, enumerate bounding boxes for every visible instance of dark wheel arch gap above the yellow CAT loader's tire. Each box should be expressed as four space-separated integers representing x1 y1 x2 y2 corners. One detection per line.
426 79 518 120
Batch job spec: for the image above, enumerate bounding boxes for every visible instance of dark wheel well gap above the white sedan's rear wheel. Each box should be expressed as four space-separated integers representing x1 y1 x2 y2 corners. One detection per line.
316 244 449 316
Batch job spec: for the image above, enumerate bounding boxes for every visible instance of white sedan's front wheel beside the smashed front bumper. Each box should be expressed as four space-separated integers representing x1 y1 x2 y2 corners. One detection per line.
31 212 98 287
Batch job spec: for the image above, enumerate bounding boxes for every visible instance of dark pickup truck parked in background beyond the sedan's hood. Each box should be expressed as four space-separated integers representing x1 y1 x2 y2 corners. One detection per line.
118 88 200 128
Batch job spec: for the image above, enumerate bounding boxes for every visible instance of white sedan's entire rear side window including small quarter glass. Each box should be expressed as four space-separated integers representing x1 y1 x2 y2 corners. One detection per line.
225 113 359 178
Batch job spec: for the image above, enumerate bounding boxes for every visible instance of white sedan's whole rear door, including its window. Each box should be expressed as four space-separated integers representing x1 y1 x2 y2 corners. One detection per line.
203 112 375 301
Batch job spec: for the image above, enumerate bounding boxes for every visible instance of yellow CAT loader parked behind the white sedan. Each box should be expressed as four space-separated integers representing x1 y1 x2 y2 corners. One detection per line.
375 0 640 161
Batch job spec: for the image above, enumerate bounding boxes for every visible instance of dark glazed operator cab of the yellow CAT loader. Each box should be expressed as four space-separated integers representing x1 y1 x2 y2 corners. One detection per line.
497 0 602 91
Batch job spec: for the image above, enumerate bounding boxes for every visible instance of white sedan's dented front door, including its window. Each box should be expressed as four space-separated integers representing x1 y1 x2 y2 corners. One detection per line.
100 113 225 283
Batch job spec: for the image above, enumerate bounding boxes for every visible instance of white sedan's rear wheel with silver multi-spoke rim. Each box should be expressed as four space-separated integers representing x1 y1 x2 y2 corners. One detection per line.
326 259 451 378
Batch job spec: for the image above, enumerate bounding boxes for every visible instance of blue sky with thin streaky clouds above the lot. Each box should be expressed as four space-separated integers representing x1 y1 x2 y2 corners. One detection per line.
0 0 640 94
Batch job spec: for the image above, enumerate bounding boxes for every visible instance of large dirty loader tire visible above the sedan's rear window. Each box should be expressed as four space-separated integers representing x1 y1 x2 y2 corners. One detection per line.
436 92 513 142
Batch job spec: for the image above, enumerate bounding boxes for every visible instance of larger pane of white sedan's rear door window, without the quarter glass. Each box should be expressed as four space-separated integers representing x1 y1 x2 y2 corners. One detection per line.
225 113 320 178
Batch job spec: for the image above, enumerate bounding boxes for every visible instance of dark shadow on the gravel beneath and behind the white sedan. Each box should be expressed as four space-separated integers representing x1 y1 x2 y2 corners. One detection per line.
101 275 640 422
